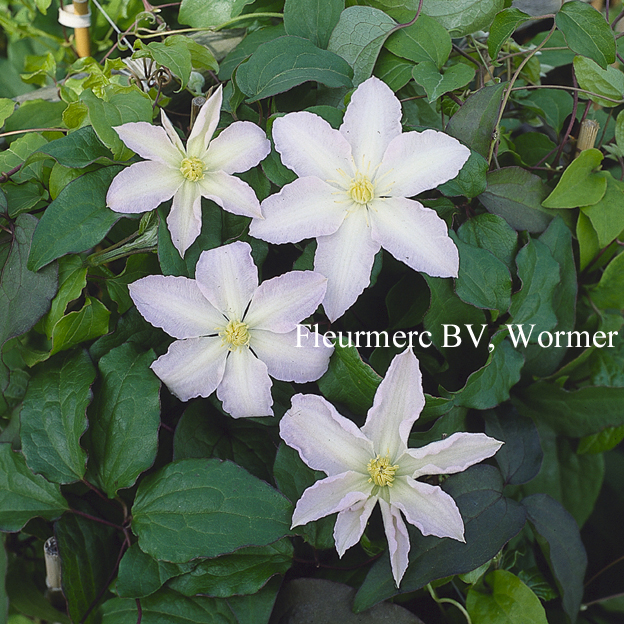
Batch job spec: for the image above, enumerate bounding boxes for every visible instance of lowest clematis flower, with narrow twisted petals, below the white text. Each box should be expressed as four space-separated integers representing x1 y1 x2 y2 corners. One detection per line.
280 350 503 587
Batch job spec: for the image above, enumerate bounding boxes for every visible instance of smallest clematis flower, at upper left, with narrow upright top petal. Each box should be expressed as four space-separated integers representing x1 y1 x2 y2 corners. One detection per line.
106 86 271 257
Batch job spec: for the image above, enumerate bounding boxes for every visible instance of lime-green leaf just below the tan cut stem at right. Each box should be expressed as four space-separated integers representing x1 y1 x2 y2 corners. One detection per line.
542 148 607 208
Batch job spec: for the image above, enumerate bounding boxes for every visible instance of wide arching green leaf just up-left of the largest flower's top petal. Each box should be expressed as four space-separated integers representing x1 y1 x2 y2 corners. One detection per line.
236 36 354 102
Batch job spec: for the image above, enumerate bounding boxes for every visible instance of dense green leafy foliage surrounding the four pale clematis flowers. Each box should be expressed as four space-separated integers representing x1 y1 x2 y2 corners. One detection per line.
0 0 624 624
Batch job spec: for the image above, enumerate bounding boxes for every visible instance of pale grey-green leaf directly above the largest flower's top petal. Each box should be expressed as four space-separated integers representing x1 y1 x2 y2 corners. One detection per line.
327 6 397 87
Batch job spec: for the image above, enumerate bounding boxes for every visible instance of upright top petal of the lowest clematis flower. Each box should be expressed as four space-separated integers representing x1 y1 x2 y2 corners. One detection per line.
362 349 425 463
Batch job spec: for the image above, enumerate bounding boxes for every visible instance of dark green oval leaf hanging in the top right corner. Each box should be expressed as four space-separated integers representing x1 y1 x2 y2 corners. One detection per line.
555 2 615 70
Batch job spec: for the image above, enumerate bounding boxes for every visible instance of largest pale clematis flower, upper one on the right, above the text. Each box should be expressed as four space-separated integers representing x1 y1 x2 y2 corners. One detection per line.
250 78 470 321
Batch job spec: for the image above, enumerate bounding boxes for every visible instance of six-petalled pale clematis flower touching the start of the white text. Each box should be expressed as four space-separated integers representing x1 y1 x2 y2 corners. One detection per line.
129 242 333 418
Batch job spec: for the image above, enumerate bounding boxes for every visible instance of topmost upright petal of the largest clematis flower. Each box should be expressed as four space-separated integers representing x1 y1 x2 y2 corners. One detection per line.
340 78 402 177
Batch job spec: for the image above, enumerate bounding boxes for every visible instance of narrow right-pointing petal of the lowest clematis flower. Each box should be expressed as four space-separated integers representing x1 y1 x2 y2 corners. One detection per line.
401 433 503 479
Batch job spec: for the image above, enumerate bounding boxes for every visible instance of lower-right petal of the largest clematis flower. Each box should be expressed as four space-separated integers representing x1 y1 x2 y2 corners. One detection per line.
370 197 459 277
